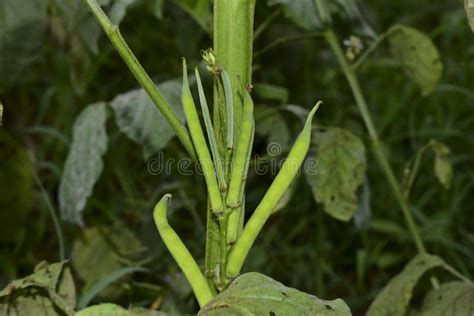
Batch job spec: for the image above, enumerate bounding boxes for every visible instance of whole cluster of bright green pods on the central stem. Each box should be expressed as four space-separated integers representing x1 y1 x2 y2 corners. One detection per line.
154 54 321 306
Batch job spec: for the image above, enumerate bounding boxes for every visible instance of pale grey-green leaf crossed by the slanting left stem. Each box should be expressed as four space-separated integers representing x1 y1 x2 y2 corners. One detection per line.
111 80 184 158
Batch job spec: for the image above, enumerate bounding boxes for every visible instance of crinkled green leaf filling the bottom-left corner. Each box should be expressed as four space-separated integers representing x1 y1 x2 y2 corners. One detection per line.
0 262 76 316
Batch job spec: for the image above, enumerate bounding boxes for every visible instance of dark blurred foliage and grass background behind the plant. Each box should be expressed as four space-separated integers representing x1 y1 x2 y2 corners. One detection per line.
0 0 474 315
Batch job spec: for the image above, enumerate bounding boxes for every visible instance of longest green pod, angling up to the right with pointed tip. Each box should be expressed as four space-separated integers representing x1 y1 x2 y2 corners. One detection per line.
226 102 321 278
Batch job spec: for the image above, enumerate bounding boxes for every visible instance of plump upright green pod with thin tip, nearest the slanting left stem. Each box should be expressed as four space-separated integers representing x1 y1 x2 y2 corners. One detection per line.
182 58 224 214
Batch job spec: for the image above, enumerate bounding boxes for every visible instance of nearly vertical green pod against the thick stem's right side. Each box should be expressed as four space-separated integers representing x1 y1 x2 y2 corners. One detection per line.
226 90 255 208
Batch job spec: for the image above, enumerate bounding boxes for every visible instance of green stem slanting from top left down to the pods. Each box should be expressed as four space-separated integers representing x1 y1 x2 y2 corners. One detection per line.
85 0 196 159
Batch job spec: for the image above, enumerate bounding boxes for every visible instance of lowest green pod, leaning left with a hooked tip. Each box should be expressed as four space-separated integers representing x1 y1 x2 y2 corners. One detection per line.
153 194 213 307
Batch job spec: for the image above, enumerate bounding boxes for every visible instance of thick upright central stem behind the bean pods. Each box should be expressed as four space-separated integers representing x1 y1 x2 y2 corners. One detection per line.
206 0 255 288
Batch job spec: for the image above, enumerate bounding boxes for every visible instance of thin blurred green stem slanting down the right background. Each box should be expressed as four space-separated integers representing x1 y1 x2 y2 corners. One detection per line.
325 29 426 253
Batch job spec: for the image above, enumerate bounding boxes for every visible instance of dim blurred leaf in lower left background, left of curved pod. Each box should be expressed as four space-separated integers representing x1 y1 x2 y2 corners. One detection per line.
72 225 146 298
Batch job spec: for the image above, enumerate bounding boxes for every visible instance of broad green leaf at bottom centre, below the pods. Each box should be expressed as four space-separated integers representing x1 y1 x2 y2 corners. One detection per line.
198 272 351 316
